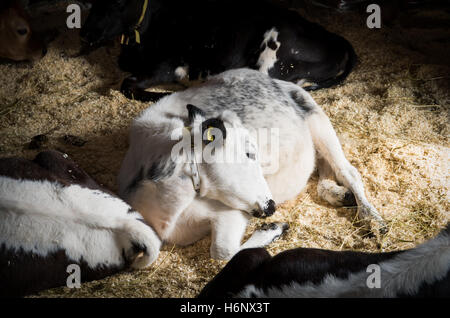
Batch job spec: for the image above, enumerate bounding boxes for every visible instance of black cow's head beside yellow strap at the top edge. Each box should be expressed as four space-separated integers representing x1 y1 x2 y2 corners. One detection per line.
80 0 153 46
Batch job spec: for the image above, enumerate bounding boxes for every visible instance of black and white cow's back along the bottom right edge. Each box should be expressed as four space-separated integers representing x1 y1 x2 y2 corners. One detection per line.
199 224 450 298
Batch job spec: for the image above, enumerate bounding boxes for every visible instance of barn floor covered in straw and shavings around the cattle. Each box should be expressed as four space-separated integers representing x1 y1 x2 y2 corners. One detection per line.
0 5 450 297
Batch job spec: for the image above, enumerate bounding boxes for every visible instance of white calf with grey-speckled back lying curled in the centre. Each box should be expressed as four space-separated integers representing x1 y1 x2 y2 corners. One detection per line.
118 69 384 259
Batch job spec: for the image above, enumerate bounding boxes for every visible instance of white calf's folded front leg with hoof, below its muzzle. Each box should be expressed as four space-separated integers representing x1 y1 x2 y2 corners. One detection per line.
210 210 287 260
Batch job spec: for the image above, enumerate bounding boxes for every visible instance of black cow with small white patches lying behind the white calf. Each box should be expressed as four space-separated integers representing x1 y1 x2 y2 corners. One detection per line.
81 0 357 101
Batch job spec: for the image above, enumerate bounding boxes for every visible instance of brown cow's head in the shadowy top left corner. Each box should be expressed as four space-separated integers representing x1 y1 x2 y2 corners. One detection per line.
0 3 46 61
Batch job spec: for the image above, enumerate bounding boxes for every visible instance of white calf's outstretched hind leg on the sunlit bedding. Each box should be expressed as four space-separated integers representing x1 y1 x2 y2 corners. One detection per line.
307 107 386 231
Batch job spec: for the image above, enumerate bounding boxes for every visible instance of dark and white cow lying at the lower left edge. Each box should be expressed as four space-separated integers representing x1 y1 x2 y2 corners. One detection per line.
0 151 160 297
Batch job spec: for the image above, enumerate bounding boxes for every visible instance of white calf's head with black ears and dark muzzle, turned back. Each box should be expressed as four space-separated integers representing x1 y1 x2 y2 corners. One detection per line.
179 105 275 217
